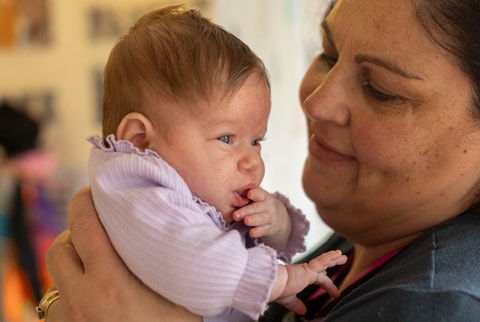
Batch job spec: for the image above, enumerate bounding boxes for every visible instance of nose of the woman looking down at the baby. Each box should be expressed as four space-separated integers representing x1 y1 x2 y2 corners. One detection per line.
302 70 351 126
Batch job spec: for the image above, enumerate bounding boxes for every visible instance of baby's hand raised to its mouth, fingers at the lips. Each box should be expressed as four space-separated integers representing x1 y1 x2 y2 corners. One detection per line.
233 187 291 250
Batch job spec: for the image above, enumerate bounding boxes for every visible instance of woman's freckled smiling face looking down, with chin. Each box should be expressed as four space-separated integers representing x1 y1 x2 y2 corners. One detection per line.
300 0 480 244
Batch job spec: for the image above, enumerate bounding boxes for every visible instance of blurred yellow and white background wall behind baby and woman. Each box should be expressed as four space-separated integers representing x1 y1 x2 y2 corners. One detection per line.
0 0 328 322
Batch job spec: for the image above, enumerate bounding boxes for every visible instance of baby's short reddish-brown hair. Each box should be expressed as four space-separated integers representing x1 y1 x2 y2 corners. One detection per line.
103 5 270 136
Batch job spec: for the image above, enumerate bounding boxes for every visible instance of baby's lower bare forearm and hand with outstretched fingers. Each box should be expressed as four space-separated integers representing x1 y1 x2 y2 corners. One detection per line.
270 250 347 315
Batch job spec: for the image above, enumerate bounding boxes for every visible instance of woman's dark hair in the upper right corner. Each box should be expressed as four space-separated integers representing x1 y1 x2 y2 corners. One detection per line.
412 0 480 119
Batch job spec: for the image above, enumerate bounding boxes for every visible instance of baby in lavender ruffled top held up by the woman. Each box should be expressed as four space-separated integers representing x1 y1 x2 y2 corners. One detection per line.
89 6 346 321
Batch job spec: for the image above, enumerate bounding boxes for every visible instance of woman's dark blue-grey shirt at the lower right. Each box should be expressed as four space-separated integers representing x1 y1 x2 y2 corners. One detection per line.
263 211 480 322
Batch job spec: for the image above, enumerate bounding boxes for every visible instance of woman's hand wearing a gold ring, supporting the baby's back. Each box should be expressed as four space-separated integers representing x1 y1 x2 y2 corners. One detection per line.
47 188 201 322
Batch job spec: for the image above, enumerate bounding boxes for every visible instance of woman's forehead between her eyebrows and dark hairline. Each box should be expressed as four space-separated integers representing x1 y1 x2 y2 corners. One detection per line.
322 0 450 79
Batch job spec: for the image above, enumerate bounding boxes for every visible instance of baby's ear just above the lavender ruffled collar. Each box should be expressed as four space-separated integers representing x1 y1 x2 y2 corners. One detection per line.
116 112 153 150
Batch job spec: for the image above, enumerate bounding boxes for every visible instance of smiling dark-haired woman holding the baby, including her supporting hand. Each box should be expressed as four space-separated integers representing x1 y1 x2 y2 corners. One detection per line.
41 0 480 322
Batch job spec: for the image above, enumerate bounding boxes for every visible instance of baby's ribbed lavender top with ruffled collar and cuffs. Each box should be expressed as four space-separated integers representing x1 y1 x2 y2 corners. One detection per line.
89 135 309 321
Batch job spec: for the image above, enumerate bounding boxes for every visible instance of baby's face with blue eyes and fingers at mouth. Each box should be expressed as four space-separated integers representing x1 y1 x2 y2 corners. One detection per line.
151 75 271 222
